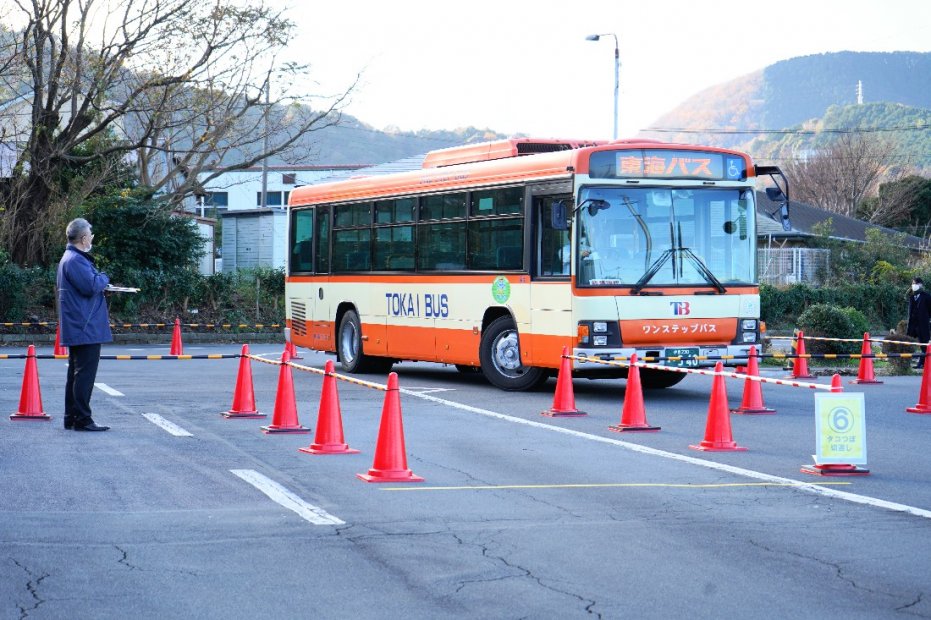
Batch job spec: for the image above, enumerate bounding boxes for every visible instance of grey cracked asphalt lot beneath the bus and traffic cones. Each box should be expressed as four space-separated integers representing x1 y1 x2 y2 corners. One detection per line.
0 345 931 619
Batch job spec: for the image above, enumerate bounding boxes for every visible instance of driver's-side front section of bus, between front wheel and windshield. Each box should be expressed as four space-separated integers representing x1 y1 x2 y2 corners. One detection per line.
525 195 575 368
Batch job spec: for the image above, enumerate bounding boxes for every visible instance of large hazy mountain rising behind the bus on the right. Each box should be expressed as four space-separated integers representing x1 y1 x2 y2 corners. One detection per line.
641 52 931 164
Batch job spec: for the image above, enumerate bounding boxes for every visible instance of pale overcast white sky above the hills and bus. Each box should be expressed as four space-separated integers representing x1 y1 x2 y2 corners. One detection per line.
262 0 931 139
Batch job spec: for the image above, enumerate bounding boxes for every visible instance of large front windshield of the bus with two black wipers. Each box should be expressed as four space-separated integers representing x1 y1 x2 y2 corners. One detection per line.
576 187 756 293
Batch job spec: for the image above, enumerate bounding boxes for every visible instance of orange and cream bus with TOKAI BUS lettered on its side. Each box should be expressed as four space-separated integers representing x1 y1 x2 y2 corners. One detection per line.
285 139 788 390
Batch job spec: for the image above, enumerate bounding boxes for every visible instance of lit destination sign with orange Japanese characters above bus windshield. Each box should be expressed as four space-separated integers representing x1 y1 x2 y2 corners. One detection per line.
589 149 747 181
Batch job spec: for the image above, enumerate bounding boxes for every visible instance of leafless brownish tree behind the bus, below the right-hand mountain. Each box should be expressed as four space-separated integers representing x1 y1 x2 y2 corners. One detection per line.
785 133 901 224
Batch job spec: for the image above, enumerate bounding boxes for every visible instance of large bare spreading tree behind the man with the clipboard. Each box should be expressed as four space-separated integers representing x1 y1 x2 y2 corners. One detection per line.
0 0 353 264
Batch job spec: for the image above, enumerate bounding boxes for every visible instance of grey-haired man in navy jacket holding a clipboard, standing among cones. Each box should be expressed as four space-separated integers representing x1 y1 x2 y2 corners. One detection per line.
57 218 113 431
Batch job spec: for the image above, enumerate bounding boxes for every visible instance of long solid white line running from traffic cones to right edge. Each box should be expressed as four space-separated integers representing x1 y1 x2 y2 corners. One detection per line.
400 389 931 519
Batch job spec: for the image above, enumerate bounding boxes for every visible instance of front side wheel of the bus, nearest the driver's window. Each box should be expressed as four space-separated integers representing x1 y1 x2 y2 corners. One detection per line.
478 316 549 392
